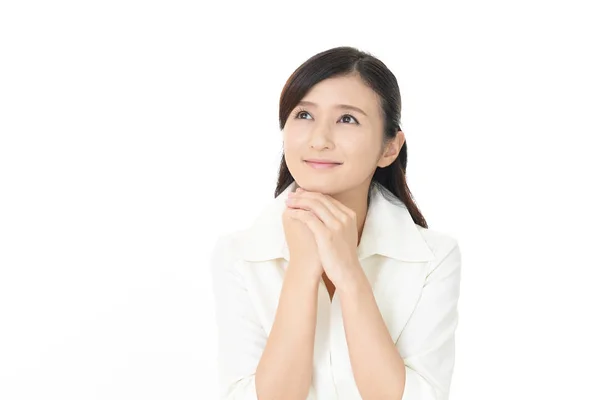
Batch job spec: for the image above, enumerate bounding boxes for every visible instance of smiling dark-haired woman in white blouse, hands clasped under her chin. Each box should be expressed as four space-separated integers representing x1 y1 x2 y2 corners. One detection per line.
211 47 461 400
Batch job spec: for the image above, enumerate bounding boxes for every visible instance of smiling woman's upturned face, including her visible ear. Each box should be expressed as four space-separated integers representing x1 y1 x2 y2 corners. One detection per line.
283 76 403 194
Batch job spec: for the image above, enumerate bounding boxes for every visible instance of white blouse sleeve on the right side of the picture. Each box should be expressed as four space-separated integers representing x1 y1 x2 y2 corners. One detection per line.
396 239 461 400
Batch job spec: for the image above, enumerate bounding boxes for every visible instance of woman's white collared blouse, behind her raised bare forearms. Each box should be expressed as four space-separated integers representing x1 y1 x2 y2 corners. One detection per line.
211 182 461 400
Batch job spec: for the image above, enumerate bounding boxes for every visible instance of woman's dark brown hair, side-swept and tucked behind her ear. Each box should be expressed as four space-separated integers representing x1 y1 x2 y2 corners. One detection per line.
275 46 428 228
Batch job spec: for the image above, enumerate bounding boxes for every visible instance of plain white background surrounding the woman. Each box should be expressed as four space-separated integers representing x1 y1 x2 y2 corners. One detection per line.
0 0 600 400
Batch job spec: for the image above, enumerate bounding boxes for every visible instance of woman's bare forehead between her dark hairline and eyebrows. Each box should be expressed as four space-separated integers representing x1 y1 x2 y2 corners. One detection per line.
302 76 379 118
